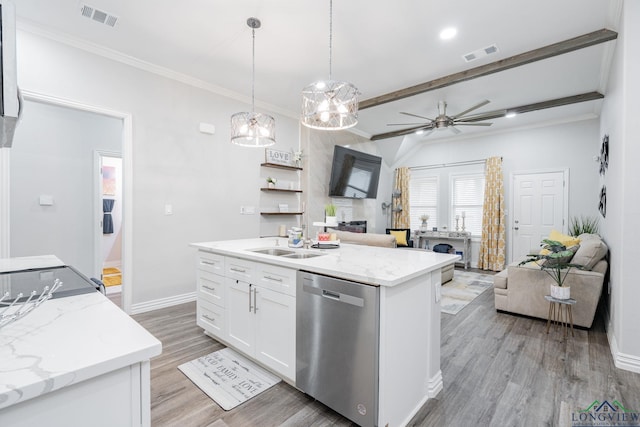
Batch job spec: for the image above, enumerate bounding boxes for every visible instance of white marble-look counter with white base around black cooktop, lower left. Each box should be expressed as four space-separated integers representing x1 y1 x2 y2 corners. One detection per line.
0 256 162 426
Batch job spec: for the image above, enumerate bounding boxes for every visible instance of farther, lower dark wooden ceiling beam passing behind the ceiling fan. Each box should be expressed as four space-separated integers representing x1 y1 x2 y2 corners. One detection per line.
371 92 604 141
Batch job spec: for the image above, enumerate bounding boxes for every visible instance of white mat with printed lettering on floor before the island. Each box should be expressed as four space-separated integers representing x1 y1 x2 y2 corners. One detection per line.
178 348 280 411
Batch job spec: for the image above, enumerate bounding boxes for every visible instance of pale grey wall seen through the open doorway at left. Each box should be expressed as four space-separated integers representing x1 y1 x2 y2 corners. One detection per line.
10 101 122 277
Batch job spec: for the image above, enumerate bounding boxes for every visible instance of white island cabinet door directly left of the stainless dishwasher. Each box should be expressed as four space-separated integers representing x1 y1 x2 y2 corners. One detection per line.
255 287 296 381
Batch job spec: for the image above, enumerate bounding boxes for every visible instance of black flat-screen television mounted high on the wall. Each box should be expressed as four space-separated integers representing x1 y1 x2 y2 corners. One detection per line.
329 145 382 199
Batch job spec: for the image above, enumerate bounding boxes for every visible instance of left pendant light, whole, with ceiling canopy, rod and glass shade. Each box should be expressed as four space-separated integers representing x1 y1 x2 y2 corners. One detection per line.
231 18 276 147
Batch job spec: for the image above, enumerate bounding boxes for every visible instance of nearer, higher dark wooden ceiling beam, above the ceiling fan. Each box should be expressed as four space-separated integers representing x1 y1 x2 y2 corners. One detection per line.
358 28 618 110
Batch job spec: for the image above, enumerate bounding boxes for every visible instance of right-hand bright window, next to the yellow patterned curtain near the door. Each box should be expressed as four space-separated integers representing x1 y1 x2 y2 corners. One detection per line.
451 174 484 236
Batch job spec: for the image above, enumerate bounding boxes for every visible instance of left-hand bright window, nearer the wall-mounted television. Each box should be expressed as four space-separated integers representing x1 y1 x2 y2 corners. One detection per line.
409 173 438 230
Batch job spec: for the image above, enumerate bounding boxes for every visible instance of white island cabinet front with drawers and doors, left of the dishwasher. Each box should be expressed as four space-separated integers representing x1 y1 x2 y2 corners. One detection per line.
197 251 296 381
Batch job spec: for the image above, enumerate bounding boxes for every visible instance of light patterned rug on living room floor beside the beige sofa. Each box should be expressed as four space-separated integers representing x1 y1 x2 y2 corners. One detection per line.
440 270 493 314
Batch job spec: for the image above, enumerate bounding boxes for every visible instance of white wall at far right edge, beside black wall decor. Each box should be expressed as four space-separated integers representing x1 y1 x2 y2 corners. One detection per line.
600 1 640 372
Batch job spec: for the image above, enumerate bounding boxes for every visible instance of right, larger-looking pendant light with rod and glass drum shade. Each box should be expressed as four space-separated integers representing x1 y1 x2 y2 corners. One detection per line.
301 0 359 130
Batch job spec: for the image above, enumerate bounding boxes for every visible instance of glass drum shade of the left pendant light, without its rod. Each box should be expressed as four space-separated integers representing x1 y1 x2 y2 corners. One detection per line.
231 112 276 147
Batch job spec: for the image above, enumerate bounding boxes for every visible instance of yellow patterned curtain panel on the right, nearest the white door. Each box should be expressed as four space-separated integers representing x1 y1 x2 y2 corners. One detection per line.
478 157 506 271
